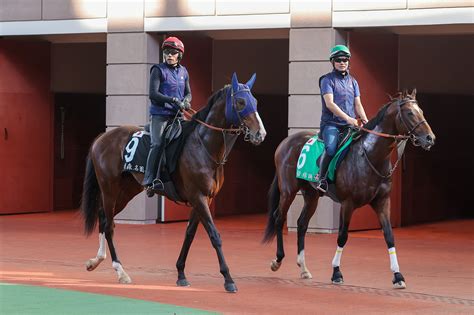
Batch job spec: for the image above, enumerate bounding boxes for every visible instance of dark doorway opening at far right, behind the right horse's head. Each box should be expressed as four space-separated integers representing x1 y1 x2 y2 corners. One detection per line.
402 94 474 226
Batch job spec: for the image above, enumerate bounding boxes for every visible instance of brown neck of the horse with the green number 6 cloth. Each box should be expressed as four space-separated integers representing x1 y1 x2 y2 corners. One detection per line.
362 104 398 164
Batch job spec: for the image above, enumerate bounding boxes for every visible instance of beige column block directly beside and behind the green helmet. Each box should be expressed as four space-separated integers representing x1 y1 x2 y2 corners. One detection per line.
290 28 335 61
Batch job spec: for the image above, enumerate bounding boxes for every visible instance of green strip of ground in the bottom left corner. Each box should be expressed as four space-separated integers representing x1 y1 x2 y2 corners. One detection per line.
0 283 218 315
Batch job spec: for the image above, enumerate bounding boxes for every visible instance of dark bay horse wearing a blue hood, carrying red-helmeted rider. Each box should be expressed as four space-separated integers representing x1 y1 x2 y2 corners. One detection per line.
81 73 266 292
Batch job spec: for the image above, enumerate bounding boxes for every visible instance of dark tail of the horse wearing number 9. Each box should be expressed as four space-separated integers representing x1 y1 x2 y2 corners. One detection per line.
81 153 100 235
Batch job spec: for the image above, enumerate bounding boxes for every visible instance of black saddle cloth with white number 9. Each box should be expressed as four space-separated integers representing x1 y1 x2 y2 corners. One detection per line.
123 130 150 174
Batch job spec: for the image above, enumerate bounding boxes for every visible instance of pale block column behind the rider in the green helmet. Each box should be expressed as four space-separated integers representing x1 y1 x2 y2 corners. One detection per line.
287 0 345 233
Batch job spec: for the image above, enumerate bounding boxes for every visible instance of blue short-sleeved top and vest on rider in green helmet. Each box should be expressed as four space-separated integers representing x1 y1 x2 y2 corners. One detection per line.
320 70 360 129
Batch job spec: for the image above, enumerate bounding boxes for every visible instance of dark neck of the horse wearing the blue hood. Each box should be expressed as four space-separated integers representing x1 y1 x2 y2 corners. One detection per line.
197 93 237 162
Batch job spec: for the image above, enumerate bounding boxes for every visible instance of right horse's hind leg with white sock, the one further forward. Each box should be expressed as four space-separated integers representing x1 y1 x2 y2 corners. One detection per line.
296 189 319 279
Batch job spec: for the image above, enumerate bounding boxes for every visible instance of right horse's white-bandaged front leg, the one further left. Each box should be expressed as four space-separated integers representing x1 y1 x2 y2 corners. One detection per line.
331 201 354 284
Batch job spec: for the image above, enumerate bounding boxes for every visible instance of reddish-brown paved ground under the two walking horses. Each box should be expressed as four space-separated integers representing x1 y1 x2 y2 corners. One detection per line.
0 211 474 314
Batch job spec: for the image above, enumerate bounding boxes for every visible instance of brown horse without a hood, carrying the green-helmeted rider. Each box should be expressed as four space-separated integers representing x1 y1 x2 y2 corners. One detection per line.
263 90 435 288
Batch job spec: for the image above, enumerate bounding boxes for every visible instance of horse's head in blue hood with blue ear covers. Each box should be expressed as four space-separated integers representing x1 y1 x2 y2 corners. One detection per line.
225 72 267 145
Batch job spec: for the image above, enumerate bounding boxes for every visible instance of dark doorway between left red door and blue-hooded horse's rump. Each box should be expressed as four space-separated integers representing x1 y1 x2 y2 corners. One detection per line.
54 93 105 210
